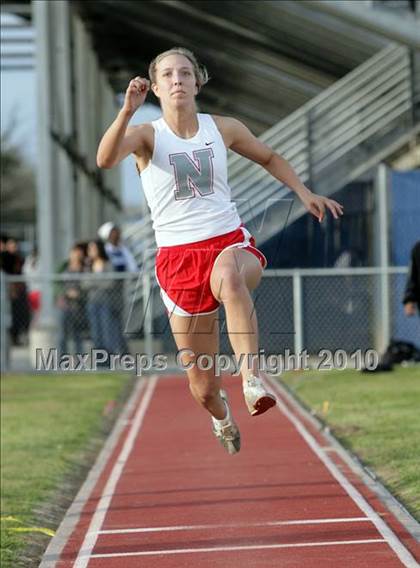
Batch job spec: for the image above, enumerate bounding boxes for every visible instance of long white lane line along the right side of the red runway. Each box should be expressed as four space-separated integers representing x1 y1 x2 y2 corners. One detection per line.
267 377 419 568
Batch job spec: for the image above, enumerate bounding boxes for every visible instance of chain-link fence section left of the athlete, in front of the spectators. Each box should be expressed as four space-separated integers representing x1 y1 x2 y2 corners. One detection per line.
1 272 141 371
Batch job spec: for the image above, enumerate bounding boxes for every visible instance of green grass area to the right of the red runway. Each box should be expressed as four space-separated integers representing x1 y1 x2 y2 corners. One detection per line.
280 367 420 520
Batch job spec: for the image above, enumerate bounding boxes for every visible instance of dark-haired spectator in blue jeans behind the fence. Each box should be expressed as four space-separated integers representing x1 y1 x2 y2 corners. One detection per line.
84 240 126 360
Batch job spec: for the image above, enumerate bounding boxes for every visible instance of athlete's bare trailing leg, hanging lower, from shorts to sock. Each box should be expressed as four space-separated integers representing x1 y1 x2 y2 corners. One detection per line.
169 311 226 420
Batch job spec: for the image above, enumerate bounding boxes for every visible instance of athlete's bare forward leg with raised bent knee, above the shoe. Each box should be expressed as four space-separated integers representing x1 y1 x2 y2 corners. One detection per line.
210 248 262 381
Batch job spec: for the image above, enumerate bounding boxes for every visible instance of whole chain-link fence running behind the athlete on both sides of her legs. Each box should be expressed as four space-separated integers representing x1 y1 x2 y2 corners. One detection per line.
1 268 420 371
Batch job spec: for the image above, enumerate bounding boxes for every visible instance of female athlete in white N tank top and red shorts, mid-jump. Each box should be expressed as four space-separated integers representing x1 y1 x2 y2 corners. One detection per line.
97 48 343 454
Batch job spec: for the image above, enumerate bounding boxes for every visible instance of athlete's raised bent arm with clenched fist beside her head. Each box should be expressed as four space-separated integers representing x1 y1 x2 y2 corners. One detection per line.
96 77 149 168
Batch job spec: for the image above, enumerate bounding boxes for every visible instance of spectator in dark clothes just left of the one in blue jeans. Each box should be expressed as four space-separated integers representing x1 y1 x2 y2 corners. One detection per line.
57 244 86 356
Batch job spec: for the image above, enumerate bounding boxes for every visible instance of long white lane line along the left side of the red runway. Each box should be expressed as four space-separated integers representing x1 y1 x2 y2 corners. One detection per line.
73 375 158 568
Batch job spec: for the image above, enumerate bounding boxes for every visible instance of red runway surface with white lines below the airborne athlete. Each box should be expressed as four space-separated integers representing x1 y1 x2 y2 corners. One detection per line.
50 377 420 568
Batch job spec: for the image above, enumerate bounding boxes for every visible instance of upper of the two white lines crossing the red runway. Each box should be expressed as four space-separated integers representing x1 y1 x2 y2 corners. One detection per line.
98 517 372 534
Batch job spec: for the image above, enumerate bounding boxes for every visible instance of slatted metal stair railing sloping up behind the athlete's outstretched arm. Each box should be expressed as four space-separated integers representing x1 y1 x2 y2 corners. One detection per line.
229 45 420 235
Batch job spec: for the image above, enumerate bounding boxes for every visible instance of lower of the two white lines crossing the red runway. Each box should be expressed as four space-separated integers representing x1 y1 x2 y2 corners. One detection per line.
91 538 386 558
